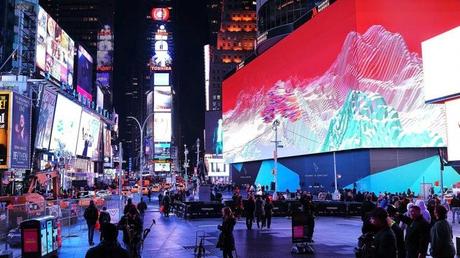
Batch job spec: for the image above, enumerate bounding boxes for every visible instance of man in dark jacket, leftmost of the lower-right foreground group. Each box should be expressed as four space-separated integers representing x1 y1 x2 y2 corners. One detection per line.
369 208 398 258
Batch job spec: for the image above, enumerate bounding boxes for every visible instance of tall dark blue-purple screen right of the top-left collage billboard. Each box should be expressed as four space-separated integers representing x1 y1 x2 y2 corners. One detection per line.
77 46 93 101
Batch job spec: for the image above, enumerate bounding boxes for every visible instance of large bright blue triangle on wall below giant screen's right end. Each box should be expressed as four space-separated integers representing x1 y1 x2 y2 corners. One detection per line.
345 156 460 194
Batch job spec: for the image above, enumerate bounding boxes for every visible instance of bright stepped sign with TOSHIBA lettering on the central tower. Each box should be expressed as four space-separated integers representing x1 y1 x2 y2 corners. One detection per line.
149 25 172 71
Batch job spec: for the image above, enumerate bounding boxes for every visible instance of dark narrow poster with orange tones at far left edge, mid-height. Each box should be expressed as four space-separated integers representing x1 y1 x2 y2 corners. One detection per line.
0 91 10 168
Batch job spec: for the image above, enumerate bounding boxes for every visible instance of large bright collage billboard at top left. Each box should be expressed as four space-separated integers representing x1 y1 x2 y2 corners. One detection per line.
35 7 75 86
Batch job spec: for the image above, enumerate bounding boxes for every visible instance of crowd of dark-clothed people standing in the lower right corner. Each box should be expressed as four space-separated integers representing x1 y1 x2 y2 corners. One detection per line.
356 191 460 258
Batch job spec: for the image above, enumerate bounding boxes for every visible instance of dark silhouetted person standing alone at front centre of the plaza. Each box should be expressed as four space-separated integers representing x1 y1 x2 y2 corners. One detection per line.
217 207 236 258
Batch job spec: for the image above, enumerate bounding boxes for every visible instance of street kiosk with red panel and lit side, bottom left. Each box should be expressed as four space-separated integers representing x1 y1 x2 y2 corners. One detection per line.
20 216 58 258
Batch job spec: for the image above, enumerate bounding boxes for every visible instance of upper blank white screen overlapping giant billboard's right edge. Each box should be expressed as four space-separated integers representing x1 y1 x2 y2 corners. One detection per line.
422 27 460 101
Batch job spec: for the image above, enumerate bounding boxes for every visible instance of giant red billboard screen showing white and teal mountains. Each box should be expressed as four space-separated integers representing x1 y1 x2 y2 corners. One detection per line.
223 0 460 162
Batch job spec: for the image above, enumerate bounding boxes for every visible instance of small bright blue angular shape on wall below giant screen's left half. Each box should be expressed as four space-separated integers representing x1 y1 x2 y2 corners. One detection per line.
255 160 300 192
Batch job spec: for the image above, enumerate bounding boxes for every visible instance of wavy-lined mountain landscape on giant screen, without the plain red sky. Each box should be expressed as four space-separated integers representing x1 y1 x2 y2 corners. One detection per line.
223 25 446 162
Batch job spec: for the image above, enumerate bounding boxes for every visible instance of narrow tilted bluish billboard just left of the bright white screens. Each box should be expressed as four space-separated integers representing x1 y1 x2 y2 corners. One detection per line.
35 89 57 149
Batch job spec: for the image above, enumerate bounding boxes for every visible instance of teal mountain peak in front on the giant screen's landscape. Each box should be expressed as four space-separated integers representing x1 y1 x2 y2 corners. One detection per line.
321 90 445 152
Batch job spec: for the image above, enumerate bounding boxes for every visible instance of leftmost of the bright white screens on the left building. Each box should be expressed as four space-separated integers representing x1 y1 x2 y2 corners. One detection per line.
50 94 82 155
